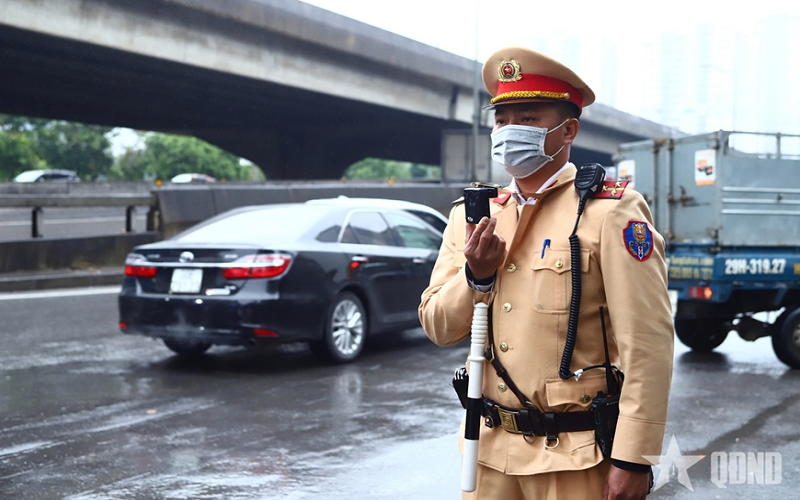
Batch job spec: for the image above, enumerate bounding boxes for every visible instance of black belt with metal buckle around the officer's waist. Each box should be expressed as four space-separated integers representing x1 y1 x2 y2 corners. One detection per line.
481 398 595 441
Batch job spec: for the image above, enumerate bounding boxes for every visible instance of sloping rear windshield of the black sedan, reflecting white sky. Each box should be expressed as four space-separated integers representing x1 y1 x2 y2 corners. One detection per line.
175 205 336 245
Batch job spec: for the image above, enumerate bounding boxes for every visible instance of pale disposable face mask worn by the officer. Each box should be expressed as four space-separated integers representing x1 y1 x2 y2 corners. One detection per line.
492 120 569 179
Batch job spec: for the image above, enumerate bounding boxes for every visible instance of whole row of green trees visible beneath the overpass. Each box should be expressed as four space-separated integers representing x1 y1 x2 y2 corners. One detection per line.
0 115 441 181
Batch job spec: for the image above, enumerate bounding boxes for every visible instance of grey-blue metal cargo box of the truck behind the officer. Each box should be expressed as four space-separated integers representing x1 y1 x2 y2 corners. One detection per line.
617 131 800 247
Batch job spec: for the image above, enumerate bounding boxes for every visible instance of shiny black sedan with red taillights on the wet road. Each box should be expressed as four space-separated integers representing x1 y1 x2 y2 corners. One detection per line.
119 203 442 362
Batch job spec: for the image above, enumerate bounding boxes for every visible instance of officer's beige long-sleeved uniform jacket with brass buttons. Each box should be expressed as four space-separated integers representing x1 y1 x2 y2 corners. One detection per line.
419 166 673 474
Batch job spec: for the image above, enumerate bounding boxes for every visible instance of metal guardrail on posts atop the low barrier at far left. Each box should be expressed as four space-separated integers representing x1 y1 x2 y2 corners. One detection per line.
0 193 157 238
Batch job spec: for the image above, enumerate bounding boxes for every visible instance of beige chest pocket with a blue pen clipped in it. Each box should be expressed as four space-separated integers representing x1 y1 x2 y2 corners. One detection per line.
531 249 591 314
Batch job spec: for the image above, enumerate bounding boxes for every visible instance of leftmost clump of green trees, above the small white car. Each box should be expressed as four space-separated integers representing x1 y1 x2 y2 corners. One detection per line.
0 115 113 180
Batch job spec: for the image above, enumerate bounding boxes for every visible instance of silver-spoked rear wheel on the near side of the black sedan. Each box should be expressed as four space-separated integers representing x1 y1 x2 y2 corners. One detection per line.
312 292 367 363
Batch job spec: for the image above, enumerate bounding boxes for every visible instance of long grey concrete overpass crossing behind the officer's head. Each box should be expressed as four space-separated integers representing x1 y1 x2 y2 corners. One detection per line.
0 0 674 179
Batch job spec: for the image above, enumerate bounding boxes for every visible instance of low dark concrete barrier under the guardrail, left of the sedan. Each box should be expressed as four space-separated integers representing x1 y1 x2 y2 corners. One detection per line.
0 231 161 273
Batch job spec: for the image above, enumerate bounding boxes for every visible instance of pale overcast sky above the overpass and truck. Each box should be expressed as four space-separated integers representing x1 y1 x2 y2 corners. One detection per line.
302 0 800 140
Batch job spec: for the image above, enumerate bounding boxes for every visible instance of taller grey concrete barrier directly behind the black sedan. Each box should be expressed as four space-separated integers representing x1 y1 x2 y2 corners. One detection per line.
154 182 465 238
